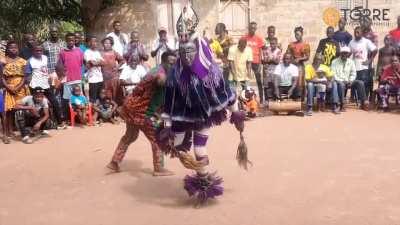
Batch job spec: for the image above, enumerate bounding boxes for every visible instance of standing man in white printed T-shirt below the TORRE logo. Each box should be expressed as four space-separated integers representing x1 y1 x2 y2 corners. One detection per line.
349 26 378 98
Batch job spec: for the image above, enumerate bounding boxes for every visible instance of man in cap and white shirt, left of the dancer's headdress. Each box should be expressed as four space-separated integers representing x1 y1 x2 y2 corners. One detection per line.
151 27 175 65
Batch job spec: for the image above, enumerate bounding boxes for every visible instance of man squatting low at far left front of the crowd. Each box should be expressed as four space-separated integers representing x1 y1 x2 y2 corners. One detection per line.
15 87 50 144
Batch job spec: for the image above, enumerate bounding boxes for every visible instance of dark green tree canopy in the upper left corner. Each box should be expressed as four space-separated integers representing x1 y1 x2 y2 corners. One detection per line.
0 0 115 38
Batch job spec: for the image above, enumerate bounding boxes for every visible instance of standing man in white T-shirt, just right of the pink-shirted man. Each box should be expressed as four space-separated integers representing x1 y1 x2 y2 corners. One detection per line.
83 36 104 103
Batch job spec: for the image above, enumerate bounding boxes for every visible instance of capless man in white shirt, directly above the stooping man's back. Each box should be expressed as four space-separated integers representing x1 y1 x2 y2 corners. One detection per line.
119 54 147 95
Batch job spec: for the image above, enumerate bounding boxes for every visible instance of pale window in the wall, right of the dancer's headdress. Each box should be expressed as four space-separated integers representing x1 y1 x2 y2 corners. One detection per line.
219 0 249 36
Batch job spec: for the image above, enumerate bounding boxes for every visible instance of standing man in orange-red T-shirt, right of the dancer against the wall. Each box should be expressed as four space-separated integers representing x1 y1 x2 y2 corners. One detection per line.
243 22 265 104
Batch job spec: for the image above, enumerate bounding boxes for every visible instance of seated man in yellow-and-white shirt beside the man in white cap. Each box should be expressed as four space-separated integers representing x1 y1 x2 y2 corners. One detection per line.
305 54 339 116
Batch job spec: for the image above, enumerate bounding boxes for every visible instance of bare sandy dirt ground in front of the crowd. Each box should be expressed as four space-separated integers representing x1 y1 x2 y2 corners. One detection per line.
0 111 400 225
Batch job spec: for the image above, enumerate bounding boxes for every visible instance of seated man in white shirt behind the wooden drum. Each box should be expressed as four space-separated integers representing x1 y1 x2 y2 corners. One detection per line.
273 53 299 99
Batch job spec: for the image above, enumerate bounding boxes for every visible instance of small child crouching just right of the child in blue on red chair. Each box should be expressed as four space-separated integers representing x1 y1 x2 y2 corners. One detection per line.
93 89 118 124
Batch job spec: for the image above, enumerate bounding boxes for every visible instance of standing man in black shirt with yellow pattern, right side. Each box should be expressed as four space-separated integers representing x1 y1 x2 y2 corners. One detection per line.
317 27 340 66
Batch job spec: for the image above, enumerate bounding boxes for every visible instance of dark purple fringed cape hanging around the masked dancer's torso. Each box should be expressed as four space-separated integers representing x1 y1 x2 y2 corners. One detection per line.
164 63 236 132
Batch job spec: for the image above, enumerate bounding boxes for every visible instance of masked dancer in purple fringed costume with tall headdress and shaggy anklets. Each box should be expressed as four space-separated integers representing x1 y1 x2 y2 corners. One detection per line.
160 3 244 203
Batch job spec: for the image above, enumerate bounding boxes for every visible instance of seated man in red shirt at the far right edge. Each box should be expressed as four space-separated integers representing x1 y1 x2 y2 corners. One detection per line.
378 55 400 110
